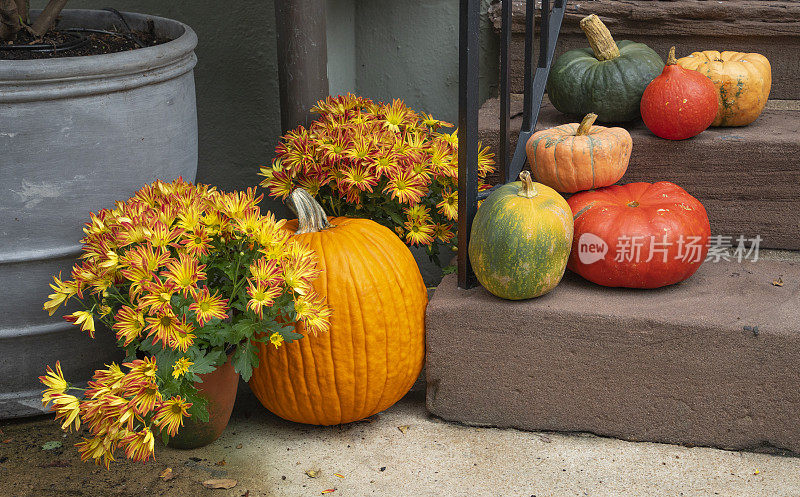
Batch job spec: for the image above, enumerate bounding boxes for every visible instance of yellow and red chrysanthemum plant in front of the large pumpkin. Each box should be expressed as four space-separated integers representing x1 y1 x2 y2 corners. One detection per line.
40 179 330 467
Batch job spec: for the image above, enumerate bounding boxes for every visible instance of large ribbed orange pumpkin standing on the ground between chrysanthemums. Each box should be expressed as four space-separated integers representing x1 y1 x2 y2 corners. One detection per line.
250 188 428 425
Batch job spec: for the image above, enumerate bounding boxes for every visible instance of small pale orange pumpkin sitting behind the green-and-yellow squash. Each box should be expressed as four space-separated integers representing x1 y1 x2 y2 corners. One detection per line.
525 114 633 193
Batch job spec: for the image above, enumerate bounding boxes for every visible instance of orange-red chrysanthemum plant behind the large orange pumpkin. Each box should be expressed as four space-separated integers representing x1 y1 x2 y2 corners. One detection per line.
260 94 494 266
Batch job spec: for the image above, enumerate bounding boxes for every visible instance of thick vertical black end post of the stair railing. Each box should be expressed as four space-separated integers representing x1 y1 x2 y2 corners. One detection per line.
458 0 480 288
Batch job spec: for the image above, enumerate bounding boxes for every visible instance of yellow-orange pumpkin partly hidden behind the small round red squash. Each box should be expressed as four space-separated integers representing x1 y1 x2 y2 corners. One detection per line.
678 50 772 126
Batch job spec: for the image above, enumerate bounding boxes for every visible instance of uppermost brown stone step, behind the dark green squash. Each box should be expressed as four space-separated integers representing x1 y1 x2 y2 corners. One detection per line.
489 0 800 100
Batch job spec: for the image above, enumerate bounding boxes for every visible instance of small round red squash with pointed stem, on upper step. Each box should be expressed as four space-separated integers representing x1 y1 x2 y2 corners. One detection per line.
641 47 718 140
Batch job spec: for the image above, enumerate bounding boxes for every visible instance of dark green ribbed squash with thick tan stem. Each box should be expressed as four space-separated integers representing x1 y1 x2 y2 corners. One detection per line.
547 14 664 122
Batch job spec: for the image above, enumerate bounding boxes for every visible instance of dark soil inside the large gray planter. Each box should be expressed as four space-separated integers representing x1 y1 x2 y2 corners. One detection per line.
0 29 172 60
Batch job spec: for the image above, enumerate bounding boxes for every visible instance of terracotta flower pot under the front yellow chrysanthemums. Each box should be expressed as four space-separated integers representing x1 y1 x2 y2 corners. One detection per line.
167 356 239 449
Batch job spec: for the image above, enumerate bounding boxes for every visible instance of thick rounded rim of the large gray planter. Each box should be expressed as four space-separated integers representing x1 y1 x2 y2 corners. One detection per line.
0 9 197 103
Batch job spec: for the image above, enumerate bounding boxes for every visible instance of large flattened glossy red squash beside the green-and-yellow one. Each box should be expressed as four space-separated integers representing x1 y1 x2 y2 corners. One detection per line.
567 181 711 288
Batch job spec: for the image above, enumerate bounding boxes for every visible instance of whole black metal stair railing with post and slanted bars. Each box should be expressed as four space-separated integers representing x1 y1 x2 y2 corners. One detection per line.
458 0 567 288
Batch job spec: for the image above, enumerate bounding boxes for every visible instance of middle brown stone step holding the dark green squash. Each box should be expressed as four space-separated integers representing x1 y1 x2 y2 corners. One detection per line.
478 95 800 250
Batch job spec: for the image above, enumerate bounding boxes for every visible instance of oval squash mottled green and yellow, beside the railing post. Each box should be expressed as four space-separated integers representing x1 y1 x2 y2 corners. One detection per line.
469 171 572 300
